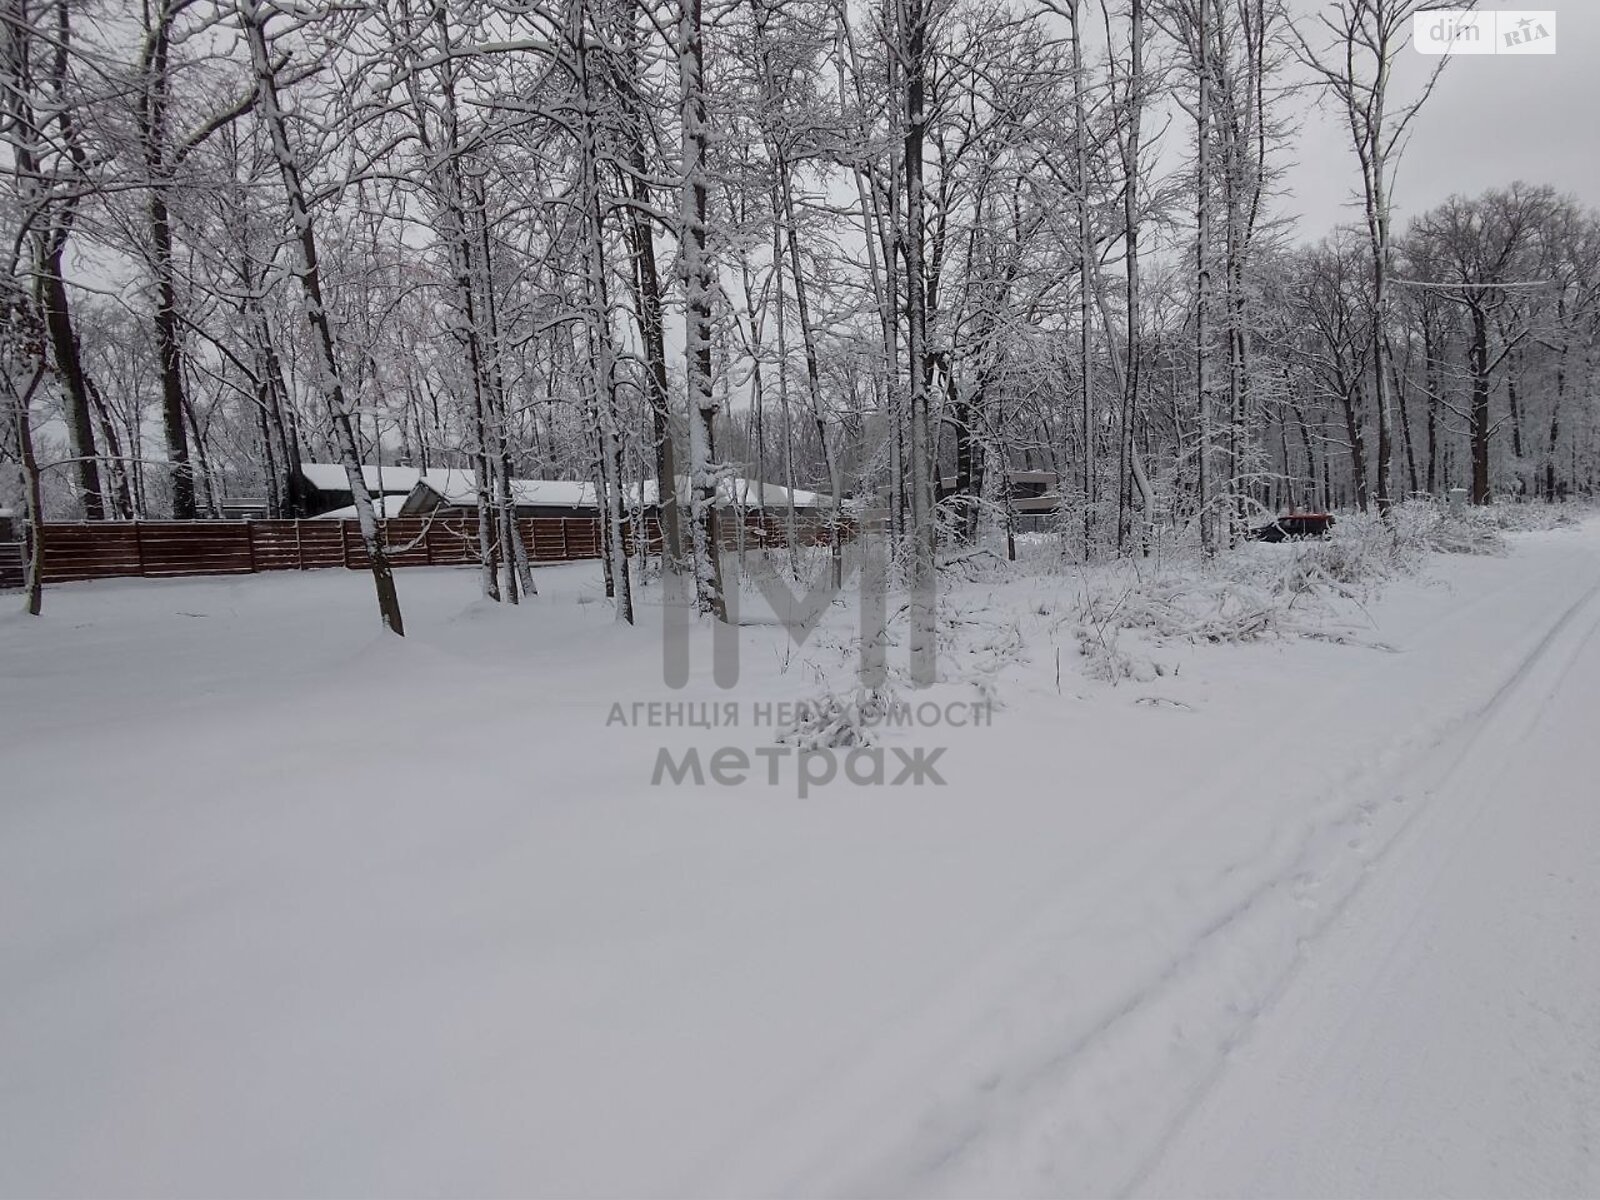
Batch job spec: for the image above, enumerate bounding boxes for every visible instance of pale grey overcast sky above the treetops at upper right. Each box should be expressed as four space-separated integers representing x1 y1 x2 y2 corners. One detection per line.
1278 0 1600 240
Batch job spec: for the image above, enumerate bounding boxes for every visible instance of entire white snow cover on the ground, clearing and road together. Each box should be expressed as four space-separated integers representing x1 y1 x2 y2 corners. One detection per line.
9 523 1600 1195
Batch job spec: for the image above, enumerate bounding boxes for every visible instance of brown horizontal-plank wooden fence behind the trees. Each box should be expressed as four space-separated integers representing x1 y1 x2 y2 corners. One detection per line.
12 515 827 587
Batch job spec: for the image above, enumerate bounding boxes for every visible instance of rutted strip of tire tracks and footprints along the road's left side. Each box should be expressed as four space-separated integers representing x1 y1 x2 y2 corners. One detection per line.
694 534 1600 1195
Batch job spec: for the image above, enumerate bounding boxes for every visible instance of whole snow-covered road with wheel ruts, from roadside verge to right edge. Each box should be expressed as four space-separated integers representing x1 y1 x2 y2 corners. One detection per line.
748 525 1600 1197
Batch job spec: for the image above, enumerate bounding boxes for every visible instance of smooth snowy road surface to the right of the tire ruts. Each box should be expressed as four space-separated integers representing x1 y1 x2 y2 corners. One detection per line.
1139 553 1600 1197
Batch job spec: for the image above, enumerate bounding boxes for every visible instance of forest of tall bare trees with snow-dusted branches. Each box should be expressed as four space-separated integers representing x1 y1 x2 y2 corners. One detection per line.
0 0 1600 632
